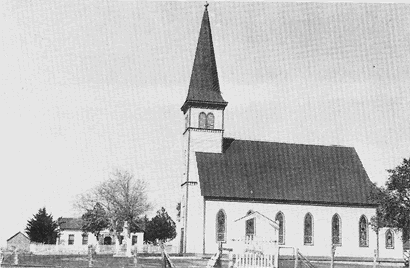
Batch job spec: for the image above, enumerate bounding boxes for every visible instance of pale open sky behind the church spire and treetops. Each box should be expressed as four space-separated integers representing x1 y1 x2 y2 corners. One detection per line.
0 0 410 246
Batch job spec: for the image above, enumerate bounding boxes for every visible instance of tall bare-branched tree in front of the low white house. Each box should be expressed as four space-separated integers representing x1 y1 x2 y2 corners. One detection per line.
75 170 151 244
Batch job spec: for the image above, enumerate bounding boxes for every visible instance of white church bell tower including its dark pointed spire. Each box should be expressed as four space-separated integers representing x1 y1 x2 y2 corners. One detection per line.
180 4 228 253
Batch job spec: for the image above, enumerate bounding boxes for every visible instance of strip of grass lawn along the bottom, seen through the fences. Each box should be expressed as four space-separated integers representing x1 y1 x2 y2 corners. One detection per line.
1 255 403 268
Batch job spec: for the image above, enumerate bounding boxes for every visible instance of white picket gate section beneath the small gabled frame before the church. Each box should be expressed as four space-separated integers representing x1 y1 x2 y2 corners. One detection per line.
234 253 275 268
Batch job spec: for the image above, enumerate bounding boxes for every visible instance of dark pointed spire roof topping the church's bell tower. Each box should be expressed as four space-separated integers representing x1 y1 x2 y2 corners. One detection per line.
181 4 228 112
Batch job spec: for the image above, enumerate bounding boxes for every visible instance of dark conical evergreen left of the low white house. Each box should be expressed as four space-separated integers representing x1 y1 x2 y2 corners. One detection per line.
25 207 59 244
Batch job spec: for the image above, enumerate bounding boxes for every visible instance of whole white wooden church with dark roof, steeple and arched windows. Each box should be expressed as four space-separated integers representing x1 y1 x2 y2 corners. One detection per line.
178 6 403 259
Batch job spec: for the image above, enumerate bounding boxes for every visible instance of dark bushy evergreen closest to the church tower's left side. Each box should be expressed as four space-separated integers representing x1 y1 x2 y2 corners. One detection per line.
144 207 177 244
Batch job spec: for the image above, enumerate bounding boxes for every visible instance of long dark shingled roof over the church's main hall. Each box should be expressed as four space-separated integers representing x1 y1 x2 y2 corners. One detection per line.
196 139 374 206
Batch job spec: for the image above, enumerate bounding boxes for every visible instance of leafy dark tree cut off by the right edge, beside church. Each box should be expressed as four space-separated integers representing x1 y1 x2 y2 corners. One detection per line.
371 158 410 241
